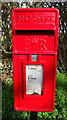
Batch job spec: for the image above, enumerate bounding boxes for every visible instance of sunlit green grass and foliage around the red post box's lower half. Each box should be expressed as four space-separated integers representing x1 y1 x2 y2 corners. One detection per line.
2 73 67 120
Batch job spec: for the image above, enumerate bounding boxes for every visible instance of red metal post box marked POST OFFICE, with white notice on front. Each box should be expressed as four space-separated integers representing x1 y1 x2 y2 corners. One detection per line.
12 8 59 112
